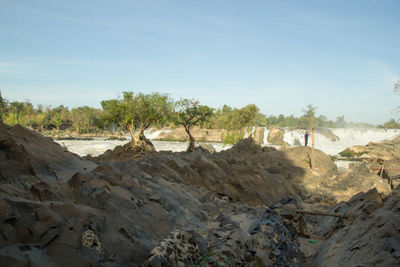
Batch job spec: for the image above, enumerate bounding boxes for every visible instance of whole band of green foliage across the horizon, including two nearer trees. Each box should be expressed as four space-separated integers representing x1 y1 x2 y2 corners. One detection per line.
0 91 380 136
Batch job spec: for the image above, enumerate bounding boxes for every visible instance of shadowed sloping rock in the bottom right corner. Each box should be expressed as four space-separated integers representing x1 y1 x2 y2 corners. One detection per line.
311 188 400 266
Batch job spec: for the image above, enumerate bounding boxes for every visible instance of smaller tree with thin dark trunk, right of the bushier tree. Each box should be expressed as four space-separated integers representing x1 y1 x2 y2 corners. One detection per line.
173 99 213 152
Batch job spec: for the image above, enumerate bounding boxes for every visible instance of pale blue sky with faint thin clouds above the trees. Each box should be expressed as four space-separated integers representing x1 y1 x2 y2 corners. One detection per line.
0 0 400 124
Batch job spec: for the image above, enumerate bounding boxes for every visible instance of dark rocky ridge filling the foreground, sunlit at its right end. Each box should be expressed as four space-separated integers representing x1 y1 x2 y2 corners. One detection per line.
0 124 398 266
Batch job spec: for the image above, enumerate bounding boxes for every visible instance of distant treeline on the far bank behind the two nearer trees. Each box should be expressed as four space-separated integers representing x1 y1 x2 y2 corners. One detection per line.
0 93 400 134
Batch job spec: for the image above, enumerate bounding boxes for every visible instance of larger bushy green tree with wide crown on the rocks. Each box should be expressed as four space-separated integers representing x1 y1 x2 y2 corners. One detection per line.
101 92 172 146
